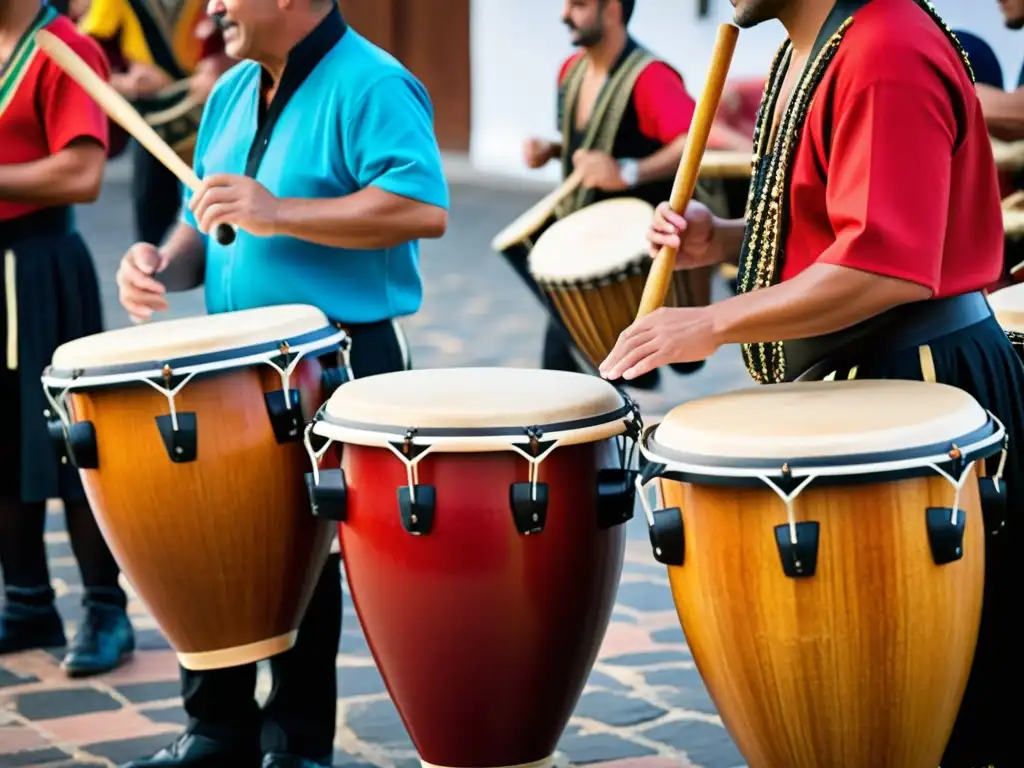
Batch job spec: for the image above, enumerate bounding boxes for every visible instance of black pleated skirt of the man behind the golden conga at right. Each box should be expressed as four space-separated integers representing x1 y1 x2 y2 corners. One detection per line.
802 318 1024 768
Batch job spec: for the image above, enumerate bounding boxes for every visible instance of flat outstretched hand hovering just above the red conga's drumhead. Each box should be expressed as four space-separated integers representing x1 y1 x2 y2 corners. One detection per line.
599 306 722 381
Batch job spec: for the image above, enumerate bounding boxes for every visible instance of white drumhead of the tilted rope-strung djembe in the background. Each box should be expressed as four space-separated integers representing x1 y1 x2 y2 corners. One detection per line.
529 198 654 283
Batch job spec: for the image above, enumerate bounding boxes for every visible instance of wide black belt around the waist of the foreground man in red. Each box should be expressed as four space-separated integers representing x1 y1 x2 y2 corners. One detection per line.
782 291 993 381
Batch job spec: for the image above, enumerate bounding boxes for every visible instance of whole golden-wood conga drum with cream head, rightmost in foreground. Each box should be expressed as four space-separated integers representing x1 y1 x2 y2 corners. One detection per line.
638 380 1005 768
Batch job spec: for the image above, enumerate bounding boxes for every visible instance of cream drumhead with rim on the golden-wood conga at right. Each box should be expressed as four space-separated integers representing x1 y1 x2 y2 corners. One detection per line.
642 380 1002 477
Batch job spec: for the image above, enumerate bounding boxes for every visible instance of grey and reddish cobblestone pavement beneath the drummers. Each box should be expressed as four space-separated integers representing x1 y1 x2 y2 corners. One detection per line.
0 171 746 768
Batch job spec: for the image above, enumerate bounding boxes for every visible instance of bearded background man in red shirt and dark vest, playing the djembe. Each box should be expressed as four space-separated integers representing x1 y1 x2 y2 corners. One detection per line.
520 0 720 388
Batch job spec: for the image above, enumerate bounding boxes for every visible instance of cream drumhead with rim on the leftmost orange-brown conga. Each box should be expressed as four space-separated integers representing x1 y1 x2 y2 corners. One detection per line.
47 304 345 384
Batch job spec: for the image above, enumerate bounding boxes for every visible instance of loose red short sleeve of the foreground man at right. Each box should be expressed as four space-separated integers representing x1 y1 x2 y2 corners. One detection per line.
806 69 961 292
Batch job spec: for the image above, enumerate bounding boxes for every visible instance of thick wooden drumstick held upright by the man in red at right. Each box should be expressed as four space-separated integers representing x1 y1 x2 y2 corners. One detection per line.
637 24 739 319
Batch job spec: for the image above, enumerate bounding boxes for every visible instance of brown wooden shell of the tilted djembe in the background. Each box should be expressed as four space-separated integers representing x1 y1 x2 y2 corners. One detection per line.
537 261 713 368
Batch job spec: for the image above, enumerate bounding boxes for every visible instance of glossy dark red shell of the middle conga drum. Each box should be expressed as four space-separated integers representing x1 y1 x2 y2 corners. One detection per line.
339 440 626 768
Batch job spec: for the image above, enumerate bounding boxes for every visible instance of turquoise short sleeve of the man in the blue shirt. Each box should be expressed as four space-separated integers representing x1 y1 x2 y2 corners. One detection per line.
343 75 449 209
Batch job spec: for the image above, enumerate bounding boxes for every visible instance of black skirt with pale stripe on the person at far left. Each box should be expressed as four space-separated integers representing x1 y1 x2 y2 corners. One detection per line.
0 208 103 502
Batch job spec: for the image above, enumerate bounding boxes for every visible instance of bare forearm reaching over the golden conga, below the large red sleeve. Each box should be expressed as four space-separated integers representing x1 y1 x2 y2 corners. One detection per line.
712 264 931 344
